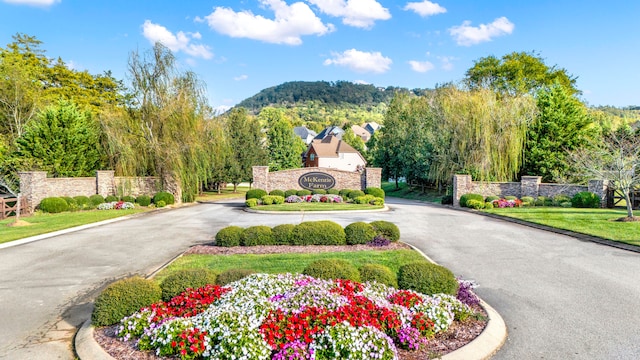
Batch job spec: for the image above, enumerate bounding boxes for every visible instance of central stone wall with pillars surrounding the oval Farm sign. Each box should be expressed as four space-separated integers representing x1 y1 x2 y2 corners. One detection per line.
253 166 382 192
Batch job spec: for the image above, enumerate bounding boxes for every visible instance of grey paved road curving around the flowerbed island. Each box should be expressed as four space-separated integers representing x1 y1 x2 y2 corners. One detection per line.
0 199 640 360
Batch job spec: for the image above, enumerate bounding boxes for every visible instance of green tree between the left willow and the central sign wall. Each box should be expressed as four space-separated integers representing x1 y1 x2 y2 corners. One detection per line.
226 107 268 192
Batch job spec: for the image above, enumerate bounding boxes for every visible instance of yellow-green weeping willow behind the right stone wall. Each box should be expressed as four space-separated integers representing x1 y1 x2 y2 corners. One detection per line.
430 86 536 182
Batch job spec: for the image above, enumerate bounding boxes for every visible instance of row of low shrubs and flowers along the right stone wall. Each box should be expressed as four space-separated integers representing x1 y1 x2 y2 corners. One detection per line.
460 191 602 209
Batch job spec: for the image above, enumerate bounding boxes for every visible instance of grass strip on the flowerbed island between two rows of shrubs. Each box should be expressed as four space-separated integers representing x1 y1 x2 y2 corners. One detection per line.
156 249 427 281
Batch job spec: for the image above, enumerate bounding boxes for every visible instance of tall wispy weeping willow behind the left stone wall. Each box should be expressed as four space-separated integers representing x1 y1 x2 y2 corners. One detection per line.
103 43 213 202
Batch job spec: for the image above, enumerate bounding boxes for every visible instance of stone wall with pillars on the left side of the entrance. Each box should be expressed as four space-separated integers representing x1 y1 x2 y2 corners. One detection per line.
18 170 176 212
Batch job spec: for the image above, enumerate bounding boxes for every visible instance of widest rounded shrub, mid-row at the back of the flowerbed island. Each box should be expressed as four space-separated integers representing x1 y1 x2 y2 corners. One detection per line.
291 220 347 245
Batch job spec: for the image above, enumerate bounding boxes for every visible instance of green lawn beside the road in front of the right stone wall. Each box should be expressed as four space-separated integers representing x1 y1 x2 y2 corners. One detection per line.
484 207 640 246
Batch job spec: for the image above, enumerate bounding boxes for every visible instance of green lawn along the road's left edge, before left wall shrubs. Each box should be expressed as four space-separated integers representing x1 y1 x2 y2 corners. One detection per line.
0 208 148 243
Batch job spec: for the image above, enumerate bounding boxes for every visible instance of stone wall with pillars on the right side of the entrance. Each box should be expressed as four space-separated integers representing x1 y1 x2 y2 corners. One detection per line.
453 175 609 207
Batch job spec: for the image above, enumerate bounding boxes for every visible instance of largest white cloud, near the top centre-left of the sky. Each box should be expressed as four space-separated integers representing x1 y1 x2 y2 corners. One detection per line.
205 0 334 45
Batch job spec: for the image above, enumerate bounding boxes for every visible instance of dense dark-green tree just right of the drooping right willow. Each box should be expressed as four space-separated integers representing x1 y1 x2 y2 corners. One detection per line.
522 85 597 182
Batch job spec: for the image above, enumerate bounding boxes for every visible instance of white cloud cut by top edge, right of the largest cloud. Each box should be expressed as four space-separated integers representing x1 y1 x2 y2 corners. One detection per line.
308 0 391 28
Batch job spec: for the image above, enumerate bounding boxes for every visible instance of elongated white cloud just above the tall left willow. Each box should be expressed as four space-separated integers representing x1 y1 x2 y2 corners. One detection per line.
142 20 213 59
